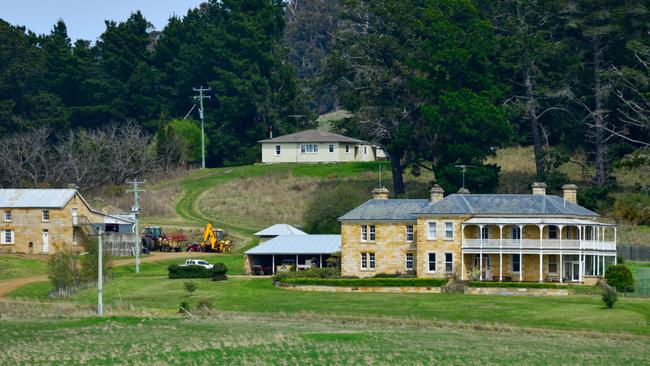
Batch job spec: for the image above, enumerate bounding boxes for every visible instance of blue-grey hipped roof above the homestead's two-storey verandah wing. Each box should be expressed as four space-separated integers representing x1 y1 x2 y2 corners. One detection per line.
417 194 599 216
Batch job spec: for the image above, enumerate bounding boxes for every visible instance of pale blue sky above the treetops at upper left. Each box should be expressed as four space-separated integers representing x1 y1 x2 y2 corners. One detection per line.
0 0 205 42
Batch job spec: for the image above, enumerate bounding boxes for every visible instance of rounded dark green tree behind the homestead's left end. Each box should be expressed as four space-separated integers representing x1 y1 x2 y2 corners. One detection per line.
303 182 372 234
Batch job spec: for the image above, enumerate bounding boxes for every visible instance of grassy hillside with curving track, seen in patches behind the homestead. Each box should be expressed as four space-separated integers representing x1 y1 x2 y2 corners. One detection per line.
91 147 650 248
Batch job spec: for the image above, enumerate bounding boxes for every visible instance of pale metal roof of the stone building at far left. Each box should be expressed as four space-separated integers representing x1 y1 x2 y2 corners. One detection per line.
0 188 77 208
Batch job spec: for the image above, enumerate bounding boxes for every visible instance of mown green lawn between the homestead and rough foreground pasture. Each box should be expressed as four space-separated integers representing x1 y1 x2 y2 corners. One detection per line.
10 275 650 335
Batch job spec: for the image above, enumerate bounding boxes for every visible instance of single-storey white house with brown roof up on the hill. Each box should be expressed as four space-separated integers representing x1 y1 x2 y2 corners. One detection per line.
259 129 386 164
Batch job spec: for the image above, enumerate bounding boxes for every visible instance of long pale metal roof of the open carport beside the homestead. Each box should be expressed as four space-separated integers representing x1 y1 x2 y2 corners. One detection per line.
245 235 341 254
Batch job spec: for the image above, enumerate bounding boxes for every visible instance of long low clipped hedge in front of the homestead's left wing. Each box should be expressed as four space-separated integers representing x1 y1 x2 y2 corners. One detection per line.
282 278 448 287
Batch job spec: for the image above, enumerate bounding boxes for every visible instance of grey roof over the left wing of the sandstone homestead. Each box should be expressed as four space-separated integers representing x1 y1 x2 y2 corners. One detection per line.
339 199 430 221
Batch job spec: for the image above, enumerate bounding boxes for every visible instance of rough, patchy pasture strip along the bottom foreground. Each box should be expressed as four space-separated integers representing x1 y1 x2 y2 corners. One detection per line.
0 314 650 365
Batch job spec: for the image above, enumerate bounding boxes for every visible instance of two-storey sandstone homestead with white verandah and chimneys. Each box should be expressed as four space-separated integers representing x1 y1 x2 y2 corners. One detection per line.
339 183 616 283
